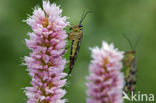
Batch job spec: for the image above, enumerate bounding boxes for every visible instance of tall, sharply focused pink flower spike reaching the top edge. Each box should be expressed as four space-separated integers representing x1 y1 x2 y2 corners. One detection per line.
25 1 69 103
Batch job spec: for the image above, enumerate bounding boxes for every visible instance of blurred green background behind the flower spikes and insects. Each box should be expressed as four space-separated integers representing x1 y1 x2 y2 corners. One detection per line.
0 0 156 103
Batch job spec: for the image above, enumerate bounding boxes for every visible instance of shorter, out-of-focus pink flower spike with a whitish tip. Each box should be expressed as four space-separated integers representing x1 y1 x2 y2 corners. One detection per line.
87 41 124 103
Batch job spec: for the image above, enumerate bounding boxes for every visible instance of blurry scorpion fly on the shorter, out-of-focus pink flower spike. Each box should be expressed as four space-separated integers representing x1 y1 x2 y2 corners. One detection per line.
123 34 140 93
